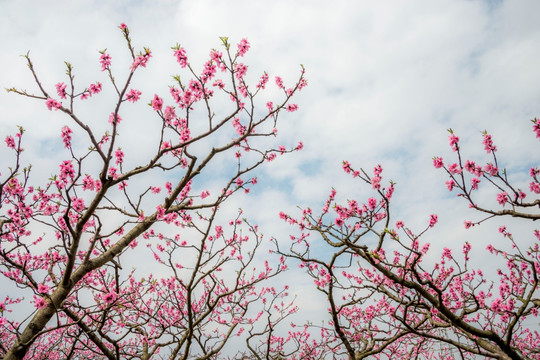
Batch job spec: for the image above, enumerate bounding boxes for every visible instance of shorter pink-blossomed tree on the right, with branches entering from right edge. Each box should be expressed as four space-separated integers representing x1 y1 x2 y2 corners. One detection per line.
276 119 540 359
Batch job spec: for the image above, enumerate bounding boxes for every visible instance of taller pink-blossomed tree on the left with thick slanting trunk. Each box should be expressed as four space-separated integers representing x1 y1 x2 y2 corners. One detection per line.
0 24 307 359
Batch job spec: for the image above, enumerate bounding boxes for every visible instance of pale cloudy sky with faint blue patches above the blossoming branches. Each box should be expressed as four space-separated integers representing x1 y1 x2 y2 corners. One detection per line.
0 0 540 352
